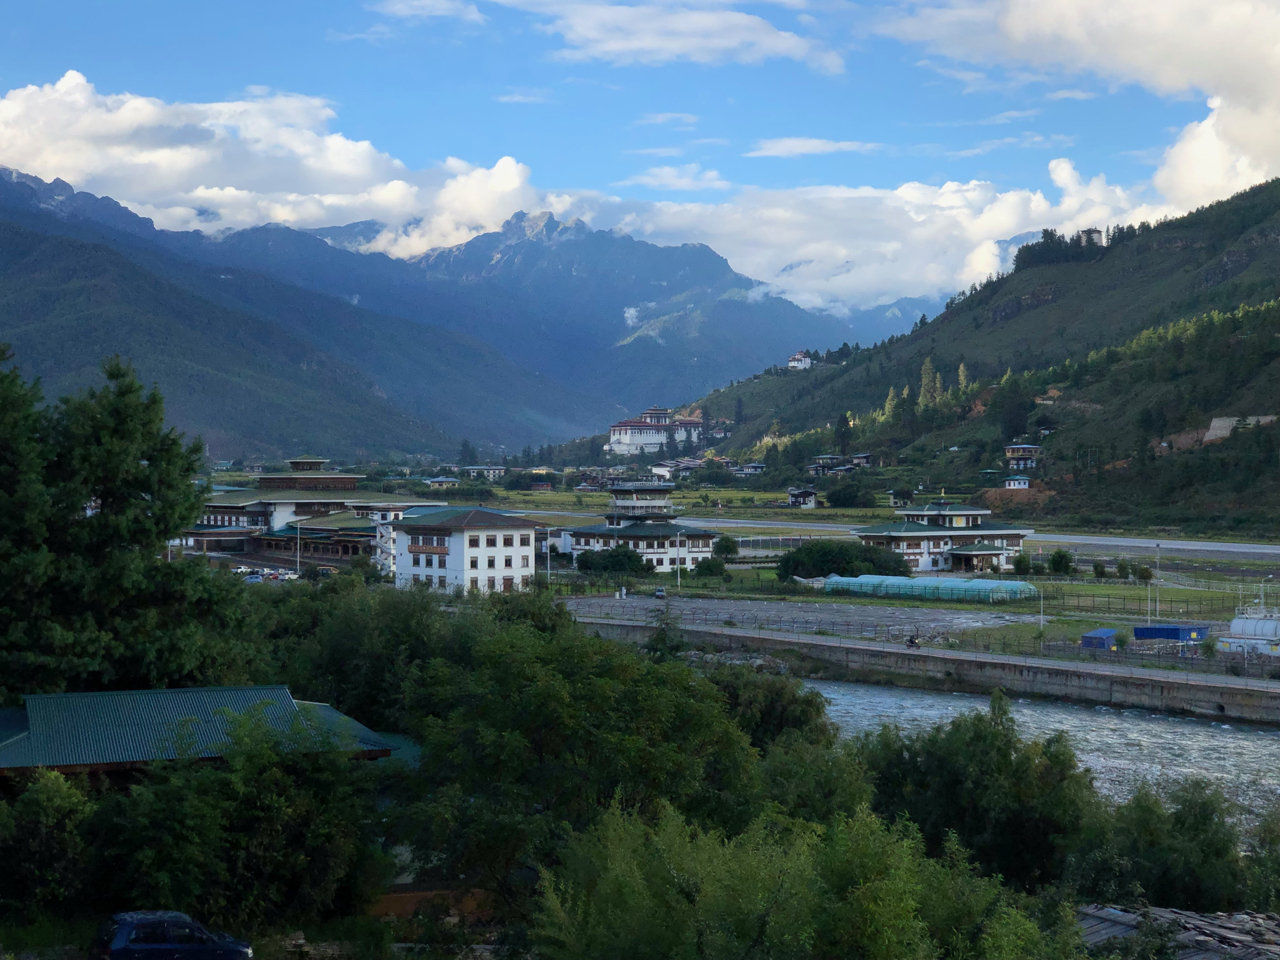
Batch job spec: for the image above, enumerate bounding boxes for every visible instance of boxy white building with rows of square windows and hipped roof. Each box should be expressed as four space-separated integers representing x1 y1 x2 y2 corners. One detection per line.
376 507 540 593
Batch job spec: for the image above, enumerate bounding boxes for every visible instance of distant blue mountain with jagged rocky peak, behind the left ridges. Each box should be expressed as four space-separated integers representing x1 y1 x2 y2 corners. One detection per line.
0 172 856 414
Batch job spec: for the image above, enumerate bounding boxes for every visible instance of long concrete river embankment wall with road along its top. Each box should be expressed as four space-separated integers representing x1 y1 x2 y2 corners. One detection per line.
579 617 1280 724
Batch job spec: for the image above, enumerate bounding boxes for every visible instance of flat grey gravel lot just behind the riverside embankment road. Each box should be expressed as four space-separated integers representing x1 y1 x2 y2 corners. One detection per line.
564 596 1038 636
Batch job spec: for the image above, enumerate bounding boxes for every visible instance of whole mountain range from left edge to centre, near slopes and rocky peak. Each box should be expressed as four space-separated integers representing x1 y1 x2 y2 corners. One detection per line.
0 169 860 457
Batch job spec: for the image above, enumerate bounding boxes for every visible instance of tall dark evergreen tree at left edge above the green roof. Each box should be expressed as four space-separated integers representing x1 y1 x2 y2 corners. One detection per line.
0 348 229 701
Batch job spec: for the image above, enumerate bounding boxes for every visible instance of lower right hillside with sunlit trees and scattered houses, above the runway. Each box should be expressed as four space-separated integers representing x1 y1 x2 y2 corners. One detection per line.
711 301 1280 538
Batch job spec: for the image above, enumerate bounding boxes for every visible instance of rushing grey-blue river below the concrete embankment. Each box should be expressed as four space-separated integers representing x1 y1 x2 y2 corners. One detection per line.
808 681 1280 810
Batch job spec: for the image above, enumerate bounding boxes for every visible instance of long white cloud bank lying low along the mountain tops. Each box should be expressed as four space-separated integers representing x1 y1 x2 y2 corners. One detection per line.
0 72 1177 311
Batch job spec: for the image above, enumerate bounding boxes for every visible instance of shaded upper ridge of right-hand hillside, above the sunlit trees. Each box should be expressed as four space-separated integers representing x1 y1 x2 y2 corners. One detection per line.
695 180 1280 449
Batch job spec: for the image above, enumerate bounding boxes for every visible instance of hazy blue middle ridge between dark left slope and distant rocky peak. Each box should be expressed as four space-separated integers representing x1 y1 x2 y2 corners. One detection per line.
0 170 609 454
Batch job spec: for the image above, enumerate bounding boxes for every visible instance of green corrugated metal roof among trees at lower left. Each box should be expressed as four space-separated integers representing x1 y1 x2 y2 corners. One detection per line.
0 686 390 769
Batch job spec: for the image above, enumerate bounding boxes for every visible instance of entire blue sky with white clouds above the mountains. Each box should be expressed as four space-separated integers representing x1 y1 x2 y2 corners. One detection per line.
0 0 1280 310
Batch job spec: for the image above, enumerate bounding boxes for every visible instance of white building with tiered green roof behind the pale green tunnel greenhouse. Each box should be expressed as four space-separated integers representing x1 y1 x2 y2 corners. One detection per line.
858 500 1036 573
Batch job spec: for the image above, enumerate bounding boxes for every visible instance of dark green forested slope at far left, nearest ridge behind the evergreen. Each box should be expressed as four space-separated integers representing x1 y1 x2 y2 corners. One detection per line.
0 221 452 456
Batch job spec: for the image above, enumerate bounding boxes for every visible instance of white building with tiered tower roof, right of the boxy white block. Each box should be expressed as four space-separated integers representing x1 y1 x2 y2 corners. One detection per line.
561 483 717 573
